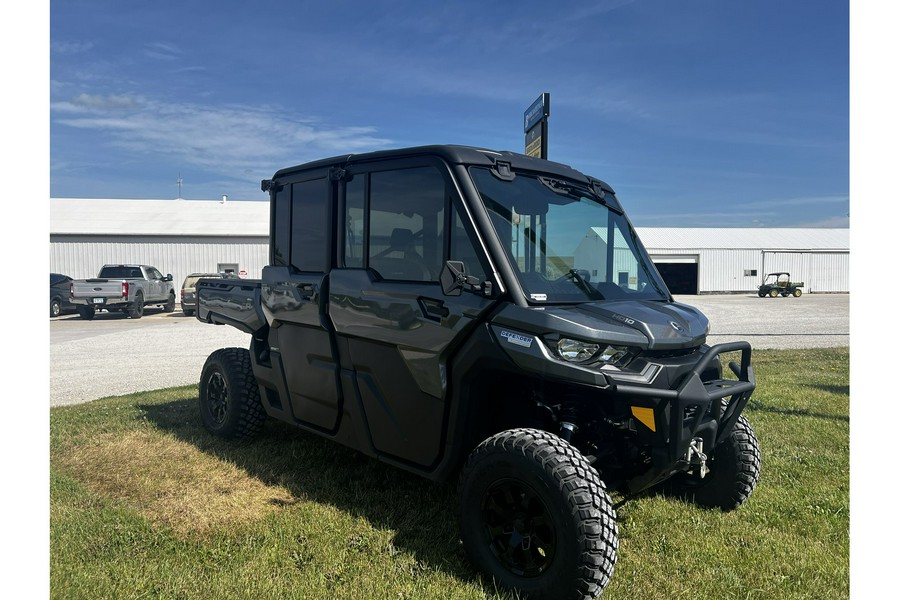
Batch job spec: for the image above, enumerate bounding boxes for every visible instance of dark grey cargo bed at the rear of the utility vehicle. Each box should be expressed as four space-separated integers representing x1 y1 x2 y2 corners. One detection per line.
195 279 266 334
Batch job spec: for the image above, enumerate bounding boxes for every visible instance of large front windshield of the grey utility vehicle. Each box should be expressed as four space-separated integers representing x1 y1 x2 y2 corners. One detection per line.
470 167 669 303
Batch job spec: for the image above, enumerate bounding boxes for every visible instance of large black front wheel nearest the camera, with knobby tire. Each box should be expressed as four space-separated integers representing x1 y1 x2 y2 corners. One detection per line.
458 429 619 599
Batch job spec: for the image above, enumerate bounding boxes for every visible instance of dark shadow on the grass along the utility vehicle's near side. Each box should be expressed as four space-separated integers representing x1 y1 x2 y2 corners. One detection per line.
137 398 477 582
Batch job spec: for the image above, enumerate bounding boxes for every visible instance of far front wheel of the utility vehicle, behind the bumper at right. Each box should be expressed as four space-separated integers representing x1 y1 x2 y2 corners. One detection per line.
666 415 760 510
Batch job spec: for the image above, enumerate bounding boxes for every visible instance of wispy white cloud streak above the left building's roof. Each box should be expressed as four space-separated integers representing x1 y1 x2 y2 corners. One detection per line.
51 94 390 185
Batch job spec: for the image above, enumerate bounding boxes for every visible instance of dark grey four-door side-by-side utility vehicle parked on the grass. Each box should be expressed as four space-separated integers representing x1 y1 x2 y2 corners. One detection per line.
197 146 760 598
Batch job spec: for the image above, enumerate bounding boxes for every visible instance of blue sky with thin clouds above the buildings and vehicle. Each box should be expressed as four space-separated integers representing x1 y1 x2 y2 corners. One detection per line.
49 0 850 227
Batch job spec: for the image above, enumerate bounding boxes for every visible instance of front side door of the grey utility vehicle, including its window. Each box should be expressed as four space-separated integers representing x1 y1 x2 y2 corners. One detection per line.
329 158 493 468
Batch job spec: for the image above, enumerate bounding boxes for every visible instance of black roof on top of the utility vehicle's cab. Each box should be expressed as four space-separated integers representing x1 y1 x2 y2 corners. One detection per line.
263 144 615 193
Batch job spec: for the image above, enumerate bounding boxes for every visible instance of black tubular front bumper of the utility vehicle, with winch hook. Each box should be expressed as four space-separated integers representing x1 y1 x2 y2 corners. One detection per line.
615 342 756 493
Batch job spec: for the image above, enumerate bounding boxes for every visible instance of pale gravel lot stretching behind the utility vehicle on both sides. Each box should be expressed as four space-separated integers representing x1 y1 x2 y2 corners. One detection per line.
50 294 850 406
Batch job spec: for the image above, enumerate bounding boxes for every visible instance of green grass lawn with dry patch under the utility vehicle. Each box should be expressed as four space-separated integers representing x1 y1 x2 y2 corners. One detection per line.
50 349 850 600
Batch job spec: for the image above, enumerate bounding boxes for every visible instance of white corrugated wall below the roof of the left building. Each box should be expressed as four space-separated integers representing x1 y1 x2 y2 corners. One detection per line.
50 235 269 289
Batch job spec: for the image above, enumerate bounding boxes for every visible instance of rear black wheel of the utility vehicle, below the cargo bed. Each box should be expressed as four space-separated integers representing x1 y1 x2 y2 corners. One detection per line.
200 348 266 440
